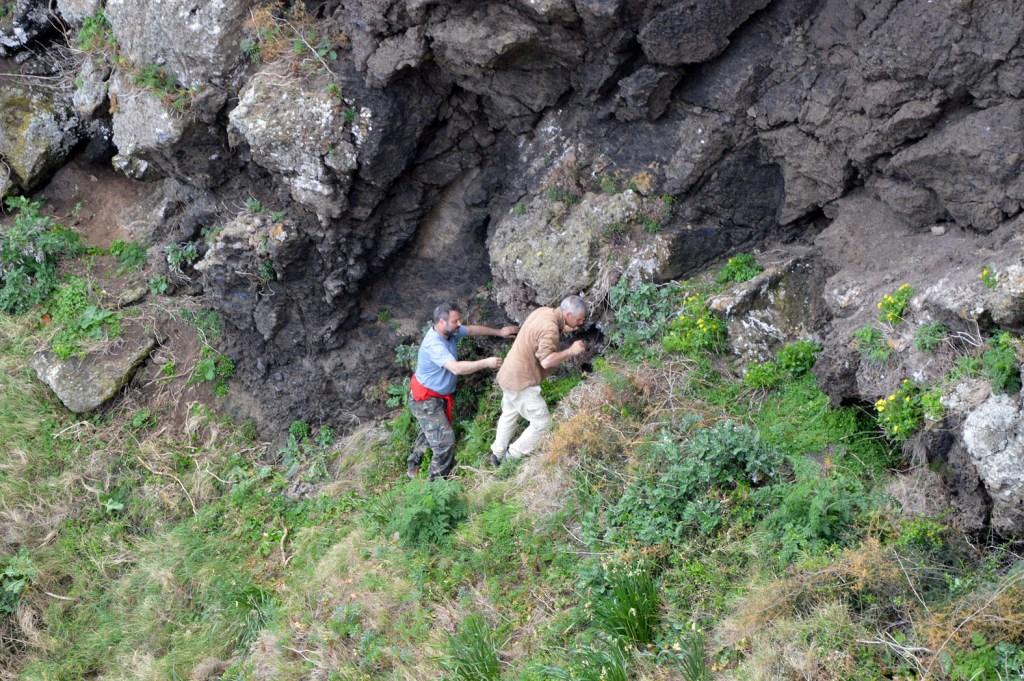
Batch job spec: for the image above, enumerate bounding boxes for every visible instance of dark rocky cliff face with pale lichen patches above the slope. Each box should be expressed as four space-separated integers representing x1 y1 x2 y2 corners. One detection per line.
0 0 1024 527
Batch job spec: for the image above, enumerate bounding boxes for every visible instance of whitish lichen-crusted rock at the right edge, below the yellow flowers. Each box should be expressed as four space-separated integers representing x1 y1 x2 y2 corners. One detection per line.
964 395 1024 538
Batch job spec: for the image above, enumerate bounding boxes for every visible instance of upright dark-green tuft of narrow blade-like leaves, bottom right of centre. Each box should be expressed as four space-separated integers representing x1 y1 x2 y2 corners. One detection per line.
591 563 659 646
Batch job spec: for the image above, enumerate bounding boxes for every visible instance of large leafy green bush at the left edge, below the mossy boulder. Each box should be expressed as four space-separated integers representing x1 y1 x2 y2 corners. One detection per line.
0 197 83 314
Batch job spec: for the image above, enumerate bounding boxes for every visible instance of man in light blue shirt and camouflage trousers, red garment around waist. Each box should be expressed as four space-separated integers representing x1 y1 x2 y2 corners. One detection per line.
406 303 519 480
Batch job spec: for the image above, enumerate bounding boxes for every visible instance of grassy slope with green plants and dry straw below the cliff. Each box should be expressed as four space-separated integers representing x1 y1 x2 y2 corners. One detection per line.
0 266 1024 680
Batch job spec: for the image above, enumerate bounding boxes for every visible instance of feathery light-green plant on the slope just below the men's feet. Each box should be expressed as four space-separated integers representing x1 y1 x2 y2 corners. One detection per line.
388 479 469 547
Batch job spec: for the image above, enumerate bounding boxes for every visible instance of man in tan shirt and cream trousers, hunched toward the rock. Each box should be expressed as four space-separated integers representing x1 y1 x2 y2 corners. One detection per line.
490 296 587 466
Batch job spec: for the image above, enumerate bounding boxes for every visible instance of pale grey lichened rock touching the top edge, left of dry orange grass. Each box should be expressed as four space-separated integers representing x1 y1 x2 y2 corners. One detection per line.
105 0 252 87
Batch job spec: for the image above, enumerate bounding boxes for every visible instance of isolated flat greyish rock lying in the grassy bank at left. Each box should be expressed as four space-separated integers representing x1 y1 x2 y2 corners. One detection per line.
32 324 157 414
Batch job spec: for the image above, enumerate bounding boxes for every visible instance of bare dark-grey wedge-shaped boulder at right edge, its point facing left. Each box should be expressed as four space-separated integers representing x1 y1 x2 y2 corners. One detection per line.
892 100 1024 231
